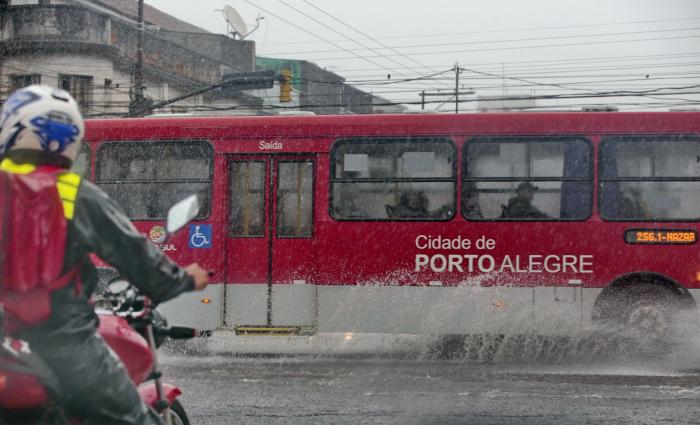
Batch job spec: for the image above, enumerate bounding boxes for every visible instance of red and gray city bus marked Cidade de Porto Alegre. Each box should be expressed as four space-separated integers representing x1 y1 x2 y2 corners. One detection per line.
78 112 700 334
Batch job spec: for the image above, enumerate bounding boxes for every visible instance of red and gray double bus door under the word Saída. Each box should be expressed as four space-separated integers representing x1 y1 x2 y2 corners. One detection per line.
224 155 316 333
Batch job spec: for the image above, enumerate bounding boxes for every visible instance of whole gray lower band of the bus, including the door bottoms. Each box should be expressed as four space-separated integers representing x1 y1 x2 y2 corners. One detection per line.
163 284 700 334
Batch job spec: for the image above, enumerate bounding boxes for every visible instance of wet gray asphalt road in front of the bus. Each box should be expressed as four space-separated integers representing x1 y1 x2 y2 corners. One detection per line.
161 354 700 425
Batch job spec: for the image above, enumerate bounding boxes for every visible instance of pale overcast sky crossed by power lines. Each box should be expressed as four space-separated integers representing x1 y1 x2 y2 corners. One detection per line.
146 0 700 110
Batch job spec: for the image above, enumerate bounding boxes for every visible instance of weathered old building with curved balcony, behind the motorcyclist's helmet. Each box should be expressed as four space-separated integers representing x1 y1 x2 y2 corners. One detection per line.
0 0 259 117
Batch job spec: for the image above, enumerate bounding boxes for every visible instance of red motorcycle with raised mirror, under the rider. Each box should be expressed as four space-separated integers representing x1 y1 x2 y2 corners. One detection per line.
0 195 199 425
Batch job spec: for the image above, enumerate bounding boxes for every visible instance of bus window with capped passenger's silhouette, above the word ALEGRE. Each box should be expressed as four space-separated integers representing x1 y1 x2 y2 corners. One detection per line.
462 137 593 221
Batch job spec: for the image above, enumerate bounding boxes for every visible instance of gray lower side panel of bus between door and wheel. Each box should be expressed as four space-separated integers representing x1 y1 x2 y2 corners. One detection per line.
317 286 601 334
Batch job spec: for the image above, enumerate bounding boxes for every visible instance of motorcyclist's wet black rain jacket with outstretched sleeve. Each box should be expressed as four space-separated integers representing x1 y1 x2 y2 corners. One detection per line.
7 150 194 343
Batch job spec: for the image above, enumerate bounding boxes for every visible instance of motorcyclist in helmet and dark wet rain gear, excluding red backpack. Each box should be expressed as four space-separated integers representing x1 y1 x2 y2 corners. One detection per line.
0 85 209 425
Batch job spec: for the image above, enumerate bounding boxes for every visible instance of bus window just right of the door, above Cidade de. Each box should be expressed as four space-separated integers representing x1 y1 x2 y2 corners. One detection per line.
331 138 456 221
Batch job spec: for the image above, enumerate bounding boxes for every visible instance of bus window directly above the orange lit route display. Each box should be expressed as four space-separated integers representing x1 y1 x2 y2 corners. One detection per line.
598 136 700 221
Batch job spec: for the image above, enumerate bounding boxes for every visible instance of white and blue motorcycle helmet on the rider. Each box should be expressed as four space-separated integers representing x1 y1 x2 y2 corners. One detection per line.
0 85 85 162
